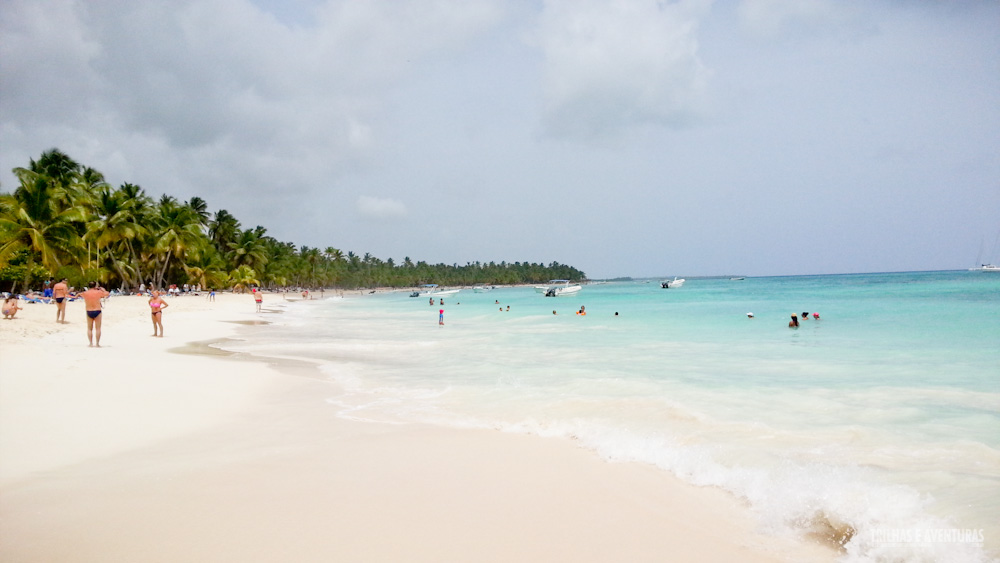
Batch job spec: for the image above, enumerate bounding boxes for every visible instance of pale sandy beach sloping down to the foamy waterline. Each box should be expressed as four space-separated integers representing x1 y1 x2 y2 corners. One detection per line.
0 294 835 562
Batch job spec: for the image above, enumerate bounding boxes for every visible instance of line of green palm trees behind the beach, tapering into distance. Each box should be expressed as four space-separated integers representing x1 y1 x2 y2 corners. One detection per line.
0 149 585 290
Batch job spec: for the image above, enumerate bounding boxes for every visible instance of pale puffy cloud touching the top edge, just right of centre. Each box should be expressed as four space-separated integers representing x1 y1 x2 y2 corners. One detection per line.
538 0 709 135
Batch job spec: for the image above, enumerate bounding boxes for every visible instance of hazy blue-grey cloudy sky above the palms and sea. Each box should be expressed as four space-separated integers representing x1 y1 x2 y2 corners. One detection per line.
0 0 1000 279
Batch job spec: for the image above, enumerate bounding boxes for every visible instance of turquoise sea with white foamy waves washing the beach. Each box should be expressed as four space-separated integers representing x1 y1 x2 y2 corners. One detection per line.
224 271 1000 561
